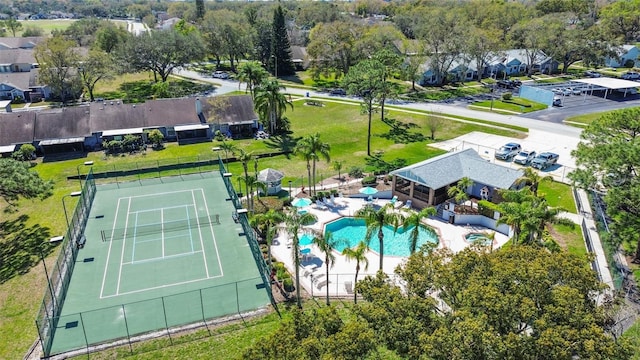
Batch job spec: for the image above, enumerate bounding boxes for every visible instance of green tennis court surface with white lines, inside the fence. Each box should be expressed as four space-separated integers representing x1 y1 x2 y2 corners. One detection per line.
51 173 269 354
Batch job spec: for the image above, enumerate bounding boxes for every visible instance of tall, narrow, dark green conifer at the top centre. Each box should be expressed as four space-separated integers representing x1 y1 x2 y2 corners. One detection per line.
269 4 295 76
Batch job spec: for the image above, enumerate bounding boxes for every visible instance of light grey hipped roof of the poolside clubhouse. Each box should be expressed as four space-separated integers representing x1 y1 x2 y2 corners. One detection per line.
391 149 523 189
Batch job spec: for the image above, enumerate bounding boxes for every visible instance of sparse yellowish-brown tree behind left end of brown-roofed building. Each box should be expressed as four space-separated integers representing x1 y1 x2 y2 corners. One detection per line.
34 36 82 102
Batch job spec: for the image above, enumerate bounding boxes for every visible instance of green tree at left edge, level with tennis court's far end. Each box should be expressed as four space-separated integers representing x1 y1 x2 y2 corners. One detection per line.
0 159 53 206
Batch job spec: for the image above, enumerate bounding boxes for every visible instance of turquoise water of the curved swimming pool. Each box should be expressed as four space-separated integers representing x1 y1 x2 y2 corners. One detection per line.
324 217 438 256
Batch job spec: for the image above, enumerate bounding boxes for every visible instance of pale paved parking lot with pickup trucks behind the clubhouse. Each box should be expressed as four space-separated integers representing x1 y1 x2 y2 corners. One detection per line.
432 130 579 183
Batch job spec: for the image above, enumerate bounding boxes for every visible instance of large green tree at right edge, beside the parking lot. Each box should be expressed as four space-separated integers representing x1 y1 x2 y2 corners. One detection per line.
570 108 640 262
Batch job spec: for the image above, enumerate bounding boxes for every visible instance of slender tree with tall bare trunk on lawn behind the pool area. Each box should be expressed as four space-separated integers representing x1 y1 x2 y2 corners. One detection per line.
342 60 385 156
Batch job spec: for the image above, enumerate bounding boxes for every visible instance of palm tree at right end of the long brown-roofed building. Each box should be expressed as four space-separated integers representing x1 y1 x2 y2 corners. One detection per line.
254 79 293 134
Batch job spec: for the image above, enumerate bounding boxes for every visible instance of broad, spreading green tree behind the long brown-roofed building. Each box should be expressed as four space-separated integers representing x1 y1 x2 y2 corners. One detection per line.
116 30 205 82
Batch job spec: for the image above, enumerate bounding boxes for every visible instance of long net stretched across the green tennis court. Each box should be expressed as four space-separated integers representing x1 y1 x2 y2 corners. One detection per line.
100 214 220 242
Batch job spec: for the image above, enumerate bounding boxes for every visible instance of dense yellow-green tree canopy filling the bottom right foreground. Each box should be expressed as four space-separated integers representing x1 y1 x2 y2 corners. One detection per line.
356 246 631 359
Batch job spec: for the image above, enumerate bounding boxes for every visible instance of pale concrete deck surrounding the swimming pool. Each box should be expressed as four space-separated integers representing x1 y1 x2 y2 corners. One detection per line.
271 198 509 296
